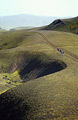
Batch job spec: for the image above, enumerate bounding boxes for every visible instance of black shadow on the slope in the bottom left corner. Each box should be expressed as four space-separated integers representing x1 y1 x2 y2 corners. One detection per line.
0 93 29 120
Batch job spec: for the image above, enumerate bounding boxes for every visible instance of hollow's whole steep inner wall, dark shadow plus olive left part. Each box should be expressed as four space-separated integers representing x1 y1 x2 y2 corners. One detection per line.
0 51 67 82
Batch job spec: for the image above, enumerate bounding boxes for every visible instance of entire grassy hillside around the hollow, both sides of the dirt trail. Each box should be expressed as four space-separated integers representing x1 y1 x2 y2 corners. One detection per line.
0 30 78 120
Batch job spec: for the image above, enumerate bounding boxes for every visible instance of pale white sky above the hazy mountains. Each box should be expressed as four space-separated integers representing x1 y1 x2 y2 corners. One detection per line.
0 0 78 17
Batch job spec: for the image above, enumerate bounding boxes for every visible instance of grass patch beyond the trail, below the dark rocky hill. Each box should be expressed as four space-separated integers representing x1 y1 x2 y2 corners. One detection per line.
43 31 78 55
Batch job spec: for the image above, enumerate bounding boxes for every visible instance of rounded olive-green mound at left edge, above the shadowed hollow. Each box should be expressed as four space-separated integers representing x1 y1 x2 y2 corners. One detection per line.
0 31 27 50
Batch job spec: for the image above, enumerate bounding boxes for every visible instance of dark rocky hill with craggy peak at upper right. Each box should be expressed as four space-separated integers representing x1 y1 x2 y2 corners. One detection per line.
44 16 78 34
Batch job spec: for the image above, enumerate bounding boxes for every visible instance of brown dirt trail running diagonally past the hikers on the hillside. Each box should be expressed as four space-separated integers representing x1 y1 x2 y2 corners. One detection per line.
35 32 78 63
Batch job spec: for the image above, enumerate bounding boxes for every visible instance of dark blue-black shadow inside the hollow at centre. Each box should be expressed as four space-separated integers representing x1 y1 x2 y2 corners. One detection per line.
19 56 66 82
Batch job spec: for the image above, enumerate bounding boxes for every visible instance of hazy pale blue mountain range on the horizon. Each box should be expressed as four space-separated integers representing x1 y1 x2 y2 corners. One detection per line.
0 14 58 29
